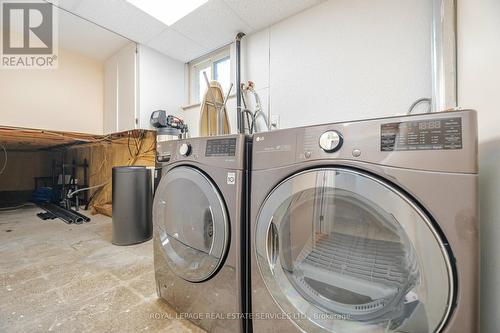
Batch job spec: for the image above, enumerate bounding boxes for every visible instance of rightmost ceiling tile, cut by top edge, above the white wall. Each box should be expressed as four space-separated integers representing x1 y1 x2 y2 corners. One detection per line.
224 0 324 30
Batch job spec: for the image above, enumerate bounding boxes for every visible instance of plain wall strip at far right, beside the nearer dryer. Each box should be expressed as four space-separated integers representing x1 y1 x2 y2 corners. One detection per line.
458 0 500 333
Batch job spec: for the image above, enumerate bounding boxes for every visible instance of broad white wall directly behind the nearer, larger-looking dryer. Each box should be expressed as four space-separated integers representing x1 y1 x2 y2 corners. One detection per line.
183 0 432 136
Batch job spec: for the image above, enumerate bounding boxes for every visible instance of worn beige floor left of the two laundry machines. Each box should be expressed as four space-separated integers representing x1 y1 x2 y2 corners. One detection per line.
0 207 203 332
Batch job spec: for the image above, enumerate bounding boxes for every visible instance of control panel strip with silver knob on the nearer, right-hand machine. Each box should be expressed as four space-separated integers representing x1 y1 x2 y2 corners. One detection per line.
252 110 477 173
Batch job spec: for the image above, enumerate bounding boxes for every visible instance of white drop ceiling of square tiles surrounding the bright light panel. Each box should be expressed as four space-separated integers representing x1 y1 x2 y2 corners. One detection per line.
50 0 324 62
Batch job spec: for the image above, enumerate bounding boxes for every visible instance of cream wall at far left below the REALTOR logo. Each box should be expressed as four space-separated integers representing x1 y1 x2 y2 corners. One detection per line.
0 49 104 134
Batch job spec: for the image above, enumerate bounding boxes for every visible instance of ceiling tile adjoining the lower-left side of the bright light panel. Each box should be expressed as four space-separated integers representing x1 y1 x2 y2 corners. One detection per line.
75 0 166 44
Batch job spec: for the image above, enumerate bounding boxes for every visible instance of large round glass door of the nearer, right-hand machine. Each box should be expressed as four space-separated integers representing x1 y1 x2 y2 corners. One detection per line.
255 168 454 333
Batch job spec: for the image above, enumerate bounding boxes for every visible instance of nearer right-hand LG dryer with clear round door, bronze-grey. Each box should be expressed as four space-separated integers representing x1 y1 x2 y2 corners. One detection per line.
251 111 479 333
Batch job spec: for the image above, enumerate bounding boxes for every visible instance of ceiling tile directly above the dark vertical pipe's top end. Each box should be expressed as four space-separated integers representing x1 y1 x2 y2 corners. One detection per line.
171 0 251 50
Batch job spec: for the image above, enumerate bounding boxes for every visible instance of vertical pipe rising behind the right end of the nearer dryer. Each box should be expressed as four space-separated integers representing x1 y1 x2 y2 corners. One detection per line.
431 0 458 112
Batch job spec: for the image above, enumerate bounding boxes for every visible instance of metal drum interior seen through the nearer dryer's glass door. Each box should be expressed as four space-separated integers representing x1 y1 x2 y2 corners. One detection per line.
284 188 420 321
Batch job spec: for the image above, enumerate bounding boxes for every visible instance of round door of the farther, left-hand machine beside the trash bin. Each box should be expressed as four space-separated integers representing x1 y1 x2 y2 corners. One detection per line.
153 166 229 282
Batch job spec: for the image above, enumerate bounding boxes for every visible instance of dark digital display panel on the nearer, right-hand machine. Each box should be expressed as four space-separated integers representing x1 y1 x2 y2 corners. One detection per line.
380 117 462 151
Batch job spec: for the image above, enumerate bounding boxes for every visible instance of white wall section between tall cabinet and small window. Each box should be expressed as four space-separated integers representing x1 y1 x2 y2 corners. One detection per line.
138 45 185 129
